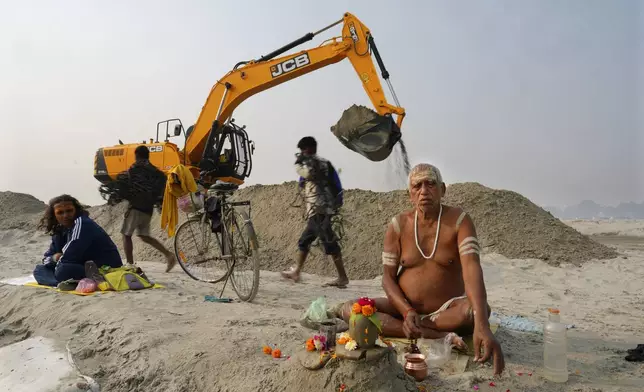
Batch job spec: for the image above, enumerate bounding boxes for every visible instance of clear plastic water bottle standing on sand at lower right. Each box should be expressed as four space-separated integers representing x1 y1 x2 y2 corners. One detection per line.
543 309 568 383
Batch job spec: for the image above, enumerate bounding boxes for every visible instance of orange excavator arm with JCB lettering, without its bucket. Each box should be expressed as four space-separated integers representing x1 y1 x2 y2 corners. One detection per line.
184 13 405 168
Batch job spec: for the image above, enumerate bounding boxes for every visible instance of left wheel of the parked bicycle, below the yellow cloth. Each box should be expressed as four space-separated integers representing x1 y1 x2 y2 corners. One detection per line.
174 217 230 283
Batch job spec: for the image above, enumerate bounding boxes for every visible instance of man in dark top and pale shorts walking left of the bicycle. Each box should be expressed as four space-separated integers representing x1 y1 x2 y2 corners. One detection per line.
121 145 176 272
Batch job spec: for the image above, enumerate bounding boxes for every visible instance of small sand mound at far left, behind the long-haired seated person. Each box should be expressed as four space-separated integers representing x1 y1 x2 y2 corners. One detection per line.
0 191 47 230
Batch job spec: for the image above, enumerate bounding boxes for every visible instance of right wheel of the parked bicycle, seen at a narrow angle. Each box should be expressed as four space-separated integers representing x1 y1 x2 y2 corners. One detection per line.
225 208 259 302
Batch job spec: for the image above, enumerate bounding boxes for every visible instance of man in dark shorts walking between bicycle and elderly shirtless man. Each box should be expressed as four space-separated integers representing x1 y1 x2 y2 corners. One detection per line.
282 136 349 288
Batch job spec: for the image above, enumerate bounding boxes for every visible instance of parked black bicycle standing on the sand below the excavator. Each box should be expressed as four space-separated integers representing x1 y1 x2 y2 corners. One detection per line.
174 183 259 302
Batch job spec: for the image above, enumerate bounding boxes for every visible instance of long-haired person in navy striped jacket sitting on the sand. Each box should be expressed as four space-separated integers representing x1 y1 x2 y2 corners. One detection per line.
33 195 123 286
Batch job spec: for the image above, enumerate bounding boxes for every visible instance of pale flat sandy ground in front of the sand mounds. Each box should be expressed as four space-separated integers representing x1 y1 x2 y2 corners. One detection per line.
0 222 644 392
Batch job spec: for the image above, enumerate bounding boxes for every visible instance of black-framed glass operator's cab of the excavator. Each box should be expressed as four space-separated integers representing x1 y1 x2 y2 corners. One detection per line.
199 119 255 185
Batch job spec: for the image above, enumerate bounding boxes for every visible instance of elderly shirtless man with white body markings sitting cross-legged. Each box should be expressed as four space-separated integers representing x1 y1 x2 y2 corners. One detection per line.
338 164 505 375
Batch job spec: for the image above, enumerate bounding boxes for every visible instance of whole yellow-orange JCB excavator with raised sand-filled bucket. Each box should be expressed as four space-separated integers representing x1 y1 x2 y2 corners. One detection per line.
94 13 405 190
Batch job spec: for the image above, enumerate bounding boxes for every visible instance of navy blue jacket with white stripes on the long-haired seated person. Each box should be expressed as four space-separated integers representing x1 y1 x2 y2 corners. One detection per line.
43 215 123 268
